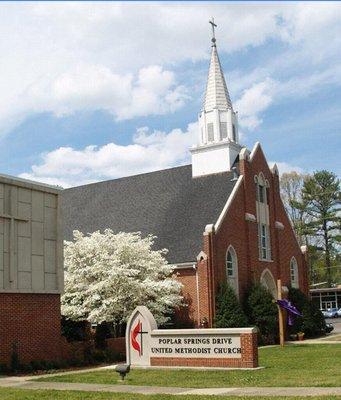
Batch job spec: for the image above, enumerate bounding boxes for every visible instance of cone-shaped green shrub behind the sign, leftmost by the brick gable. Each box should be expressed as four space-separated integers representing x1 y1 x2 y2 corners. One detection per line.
214 282 247 328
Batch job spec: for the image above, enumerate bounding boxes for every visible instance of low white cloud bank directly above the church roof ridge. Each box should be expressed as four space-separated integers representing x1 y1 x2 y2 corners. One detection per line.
20 123 198 187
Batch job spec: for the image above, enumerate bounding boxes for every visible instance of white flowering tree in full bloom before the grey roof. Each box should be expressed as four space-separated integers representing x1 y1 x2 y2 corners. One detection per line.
62 229 182 324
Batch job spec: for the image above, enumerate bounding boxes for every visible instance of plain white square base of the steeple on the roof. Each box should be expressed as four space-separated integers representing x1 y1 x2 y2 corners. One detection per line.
191 141 242 178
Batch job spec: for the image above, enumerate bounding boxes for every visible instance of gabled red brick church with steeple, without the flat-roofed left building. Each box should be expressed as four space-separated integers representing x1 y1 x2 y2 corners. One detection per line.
62 27 308 326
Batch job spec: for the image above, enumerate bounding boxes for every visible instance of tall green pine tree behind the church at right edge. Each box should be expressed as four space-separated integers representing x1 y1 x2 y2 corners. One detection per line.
301 170 341 286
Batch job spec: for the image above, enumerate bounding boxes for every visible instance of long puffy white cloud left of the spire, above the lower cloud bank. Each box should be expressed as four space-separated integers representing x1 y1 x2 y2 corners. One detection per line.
0 64 189 131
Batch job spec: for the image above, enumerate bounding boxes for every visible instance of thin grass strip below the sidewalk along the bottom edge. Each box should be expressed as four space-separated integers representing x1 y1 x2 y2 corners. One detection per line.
0 388 338 400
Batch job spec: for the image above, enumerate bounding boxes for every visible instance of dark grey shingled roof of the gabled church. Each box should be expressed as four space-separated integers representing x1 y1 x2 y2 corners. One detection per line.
62 165 235 263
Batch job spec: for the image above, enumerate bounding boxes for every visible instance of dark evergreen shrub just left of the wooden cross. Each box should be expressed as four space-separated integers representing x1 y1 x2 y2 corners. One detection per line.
244 284 278 344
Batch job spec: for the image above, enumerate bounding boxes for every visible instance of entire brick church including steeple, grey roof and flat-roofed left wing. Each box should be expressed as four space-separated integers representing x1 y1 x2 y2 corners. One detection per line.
0 22 308 363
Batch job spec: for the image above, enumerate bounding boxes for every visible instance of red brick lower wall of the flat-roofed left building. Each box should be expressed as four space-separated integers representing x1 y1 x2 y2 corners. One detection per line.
0 293 61 364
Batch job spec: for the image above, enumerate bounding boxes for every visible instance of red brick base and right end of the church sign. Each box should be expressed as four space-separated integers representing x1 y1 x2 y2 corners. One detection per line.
150 333 258 368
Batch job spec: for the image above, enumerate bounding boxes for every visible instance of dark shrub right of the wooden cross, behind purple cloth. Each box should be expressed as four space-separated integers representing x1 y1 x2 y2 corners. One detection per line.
288 288 326 337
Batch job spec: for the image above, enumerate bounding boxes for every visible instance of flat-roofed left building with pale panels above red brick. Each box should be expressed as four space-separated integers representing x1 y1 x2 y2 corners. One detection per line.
0 176 63 365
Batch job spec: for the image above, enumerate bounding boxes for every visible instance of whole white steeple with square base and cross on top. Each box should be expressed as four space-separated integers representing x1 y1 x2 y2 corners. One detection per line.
191 18 241 177
